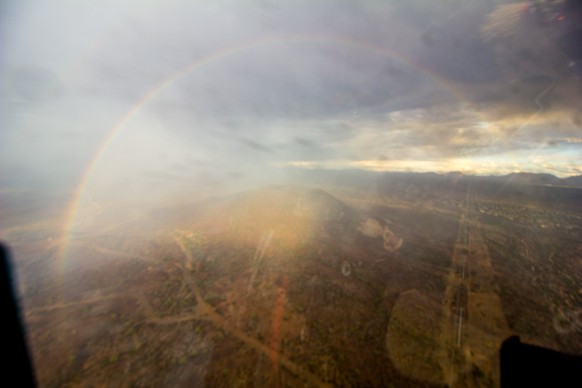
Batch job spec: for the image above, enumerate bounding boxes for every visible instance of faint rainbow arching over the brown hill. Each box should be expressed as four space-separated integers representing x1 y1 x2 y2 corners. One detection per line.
58 35 482 269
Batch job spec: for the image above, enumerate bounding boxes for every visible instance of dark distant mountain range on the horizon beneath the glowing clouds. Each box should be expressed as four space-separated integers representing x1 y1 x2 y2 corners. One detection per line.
290 169 582 210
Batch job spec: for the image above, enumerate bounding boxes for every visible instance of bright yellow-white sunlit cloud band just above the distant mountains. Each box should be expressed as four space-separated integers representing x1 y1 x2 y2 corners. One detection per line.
298 107 582 177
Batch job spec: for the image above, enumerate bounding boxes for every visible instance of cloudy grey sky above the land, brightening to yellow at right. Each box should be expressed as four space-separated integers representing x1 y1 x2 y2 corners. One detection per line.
0 0 582 203
